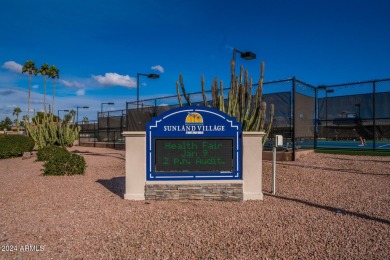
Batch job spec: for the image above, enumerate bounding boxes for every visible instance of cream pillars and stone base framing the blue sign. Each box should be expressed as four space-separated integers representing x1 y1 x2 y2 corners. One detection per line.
123 132 264 200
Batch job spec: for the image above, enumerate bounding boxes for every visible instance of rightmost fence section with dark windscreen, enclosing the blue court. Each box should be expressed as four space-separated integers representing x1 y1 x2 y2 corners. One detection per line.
315 79 390 150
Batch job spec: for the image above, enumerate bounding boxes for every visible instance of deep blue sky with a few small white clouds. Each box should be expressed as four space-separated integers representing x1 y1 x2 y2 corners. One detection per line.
0 0 390 120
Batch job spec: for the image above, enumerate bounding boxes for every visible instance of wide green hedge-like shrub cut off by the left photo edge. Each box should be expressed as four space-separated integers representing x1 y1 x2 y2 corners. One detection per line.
0 135 35 159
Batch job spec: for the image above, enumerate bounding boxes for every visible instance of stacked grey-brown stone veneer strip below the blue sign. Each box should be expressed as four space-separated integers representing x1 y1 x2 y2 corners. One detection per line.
145 183 243 201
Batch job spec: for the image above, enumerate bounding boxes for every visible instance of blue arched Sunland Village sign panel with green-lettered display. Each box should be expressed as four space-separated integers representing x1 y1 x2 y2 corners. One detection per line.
146 106 242 181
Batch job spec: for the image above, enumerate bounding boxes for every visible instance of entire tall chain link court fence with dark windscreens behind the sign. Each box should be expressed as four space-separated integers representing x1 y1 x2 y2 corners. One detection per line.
80 78 390 157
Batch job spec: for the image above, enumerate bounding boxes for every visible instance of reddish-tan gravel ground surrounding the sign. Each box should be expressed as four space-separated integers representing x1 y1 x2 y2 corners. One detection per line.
0 146 390 259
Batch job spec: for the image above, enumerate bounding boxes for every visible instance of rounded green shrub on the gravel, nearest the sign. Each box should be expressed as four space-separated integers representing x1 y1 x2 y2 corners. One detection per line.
43 152 86 175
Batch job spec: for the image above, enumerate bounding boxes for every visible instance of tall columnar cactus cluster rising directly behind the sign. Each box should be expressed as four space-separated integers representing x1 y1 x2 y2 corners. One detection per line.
176 60 275 144
